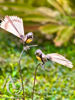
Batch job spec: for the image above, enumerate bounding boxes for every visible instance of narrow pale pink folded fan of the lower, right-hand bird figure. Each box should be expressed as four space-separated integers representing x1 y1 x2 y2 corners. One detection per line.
46 53 73 68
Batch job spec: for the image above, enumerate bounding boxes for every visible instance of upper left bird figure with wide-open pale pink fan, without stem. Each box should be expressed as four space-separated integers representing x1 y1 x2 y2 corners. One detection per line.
0 16 33 44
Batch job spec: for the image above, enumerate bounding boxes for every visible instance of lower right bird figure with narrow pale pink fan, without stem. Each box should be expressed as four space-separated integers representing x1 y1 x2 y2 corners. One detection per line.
35 49 73 68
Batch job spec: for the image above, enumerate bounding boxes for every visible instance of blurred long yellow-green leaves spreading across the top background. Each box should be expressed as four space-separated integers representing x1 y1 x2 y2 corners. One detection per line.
0 0 75 46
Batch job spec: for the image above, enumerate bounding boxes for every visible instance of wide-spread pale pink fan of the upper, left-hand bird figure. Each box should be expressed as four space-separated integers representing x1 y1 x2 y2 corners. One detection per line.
0 16 24 38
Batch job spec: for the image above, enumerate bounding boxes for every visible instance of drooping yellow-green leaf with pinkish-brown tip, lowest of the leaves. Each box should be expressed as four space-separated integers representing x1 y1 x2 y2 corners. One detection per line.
54 26 74 46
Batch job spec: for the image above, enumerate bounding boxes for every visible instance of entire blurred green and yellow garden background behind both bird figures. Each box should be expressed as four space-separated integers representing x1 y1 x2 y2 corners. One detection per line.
0 0 75 100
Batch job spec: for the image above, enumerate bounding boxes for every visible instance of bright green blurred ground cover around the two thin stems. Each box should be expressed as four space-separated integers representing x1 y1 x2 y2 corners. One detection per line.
0 33 75 100
